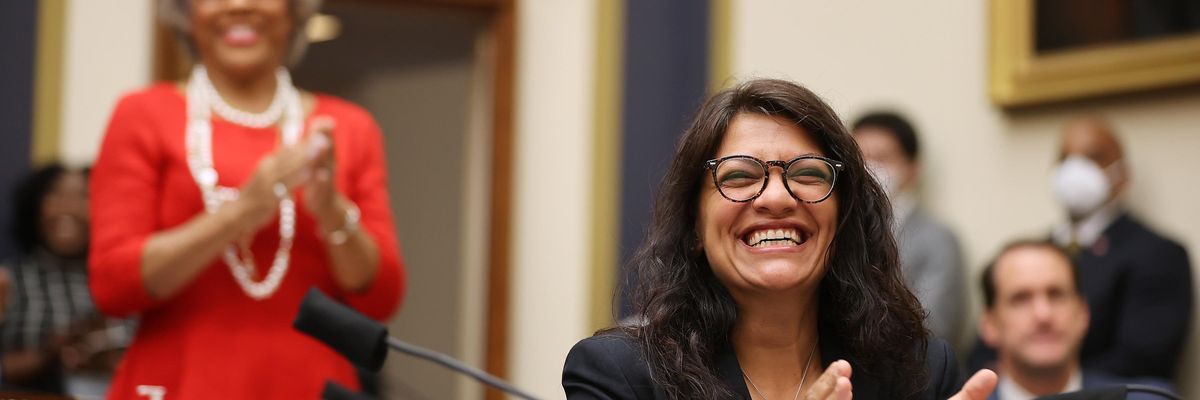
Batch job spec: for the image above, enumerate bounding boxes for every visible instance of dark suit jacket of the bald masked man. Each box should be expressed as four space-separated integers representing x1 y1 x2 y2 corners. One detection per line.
1075 214 1193 380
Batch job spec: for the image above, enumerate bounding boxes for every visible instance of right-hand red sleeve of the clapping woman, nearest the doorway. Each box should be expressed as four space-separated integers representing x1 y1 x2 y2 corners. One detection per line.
338 111 406 321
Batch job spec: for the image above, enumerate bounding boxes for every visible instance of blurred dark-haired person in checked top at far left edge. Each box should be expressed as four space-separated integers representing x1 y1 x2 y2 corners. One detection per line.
0 165 128 395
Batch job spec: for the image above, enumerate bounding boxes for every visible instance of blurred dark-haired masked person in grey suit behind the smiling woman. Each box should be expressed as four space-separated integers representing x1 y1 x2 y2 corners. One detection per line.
853 112 966 344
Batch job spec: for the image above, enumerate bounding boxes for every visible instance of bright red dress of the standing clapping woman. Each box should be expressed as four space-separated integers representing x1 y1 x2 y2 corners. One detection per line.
89 83 404 400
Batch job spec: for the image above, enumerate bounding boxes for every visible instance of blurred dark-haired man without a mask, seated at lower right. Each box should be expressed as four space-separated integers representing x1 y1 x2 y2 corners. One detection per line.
979 240 1170 400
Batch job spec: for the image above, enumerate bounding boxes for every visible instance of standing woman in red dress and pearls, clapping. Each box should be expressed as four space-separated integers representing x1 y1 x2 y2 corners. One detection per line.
90 0 404 399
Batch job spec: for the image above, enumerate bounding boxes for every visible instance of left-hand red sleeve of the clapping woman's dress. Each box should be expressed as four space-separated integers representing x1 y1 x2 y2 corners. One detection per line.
88 94 163 316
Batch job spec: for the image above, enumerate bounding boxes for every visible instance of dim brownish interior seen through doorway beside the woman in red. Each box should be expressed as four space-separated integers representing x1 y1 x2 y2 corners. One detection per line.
293 1 491 399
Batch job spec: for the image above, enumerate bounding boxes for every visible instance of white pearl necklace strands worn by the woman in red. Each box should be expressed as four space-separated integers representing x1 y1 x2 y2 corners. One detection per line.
185 65 301 300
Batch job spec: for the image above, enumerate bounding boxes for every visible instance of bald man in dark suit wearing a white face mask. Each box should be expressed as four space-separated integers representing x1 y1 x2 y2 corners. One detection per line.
1052 118 1193 380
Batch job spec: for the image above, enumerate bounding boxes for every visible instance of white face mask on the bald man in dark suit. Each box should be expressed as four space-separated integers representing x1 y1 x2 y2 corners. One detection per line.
1051 155 1120 216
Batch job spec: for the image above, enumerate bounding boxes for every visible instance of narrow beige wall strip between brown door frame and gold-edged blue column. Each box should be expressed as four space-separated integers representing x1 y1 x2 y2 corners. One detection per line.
509 0 595 399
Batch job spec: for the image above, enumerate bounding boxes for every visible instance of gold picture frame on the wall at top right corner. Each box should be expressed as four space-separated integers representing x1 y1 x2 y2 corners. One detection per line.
989 0 1200 107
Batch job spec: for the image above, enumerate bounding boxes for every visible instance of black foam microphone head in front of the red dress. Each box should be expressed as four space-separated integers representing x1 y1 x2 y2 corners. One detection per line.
292 288 388 371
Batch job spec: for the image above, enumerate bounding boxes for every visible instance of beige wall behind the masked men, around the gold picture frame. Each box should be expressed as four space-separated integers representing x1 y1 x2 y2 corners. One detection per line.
731 0 1200 395
